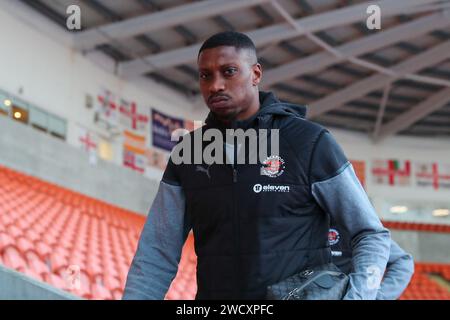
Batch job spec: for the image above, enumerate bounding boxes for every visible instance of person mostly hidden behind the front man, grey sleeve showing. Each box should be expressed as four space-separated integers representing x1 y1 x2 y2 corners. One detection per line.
328 225 414 300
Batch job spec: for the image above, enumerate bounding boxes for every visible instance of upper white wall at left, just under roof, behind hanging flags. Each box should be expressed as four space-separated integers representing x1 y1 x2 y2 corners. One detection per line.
0 2 194 179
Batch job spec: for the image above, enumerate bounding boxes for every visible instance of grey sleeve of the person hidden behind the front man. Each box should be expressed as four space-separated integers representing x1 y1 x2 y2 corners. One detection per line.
377 240 414 300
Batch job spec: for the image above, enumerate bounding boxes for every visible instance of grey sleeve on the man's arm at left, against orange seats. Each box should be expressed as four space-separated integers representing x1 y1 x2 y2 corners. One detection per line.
123 181 191 300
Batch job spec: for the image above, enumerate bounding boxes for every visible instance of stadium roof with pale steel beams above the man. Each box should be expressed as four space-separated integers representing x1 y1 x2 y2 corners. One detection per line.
16 0 450 141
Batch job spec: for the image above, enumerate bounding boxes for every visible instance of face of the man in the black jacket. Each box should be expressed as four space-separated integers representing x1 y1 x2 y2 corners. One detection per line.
198 46 262 120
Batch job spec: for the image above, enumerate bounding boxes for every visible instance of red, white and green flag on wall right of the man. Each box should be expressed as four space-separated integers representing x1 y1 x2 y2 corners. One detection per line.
372 159 411 186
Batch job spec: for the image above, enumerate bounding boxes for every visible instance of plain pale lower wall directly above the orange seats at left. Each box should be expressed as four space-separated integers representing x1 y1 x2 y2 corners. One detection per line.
0 116 158 215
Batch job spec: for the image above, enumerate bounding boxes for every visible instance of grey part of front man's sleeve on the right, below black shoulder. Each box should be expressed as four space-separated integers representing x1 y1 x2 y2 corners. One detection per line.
312 163 390 300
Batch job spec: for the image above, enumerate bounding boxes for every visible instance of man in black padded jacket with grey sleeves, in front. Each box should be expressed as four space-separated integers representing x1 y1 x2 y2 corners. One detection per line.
124 32 390 299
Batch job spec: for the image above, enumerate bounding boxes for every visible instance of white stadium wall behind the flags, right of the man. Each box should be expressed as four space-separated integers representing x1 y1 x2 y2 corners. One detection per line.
331 129 450 224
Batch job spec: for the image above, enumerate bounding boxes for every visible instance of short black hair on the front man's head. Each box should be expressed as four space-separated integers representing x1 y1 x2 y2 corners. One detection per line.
197 31 256 62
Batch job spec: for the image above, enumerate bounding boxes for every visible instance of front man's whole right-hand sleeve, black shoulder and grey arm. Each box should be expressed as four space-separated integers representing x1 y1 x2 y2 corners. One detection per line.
310 131 390 300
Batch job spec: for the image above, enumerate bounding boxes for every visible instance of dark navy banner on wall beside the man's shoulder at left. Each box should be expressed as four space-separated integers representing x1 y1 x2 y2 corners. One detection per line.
152 109 184 152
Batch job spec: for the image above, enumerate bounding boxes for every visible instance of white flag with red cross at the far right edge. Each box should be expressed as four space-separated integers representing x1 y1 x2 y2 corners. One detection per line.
415 162 450 190
